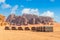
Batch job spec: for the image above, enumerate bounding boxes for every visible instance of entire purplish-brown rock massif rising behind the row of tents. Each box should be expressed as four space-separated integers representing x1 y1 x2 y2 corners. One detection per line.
6 14 53 25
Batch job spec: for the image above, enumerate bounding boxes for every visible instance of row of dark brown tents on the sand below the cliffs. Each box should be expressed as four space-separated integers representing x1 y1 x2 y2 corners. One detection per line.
5 26 53 32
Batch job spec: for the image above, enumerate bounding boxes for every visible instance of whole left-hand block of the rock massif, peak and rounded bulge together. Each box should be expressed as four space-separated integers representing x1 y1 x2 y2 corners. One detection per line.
6 14 27 25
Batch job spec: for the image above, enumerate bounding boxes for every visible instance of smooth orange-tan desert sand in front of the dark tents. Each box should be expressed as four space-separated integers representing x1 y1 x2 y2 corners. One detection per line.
0 24 60 40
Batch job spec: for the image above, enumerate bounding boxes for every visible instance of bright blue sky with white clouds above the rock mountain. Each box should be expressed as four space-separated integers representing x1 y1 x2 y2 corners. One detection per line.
0 0 60 22
